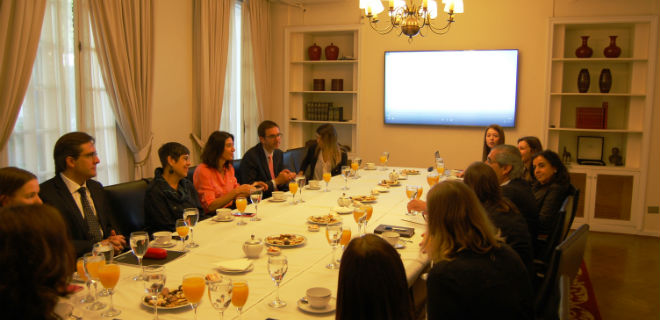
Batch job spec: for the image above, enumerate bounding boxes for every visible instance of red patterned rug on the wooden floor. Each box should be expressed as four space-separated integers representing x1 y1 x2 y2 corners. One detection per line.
570 261 602 320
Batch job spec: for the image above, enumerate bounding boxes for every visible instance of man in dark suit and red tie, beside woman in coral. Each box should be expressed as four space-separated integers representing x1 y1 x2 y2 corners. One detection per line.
239 120 296 198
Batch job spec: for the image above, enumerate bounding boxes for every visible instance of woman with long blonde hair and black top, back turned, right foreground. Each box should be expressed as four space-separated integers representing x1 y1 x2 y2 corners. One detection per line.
422 181 534 319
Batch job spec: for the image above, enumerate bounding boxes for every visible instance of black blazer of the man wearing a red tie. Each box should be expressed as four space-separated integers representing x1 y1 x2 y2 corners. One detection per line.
238 142 289 198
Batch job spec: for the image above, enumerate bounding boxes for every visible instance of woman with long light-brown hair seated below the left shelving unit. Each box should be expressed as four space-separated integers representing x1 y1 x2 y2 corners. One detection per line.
298 123 348 180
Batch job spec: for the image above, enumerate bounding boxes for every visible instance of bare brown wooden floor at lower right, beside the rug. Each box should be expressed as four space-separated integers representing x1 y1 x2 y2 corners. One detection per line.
584 232 660 320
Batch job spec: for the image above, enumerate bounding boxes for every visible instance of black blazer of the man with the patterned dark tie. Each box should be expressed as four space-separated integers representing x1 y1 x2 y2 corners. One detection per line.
39 174 116 256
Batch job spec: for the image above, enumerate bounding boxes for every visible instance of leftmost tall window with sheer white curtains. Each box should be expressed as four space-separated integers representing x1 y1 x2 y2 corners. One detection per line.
7 0 119 184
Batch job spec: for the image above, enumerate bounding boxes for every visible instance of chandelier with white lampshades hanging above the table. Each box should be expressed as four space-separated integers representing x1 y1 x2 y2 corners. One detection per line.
360 0 463 41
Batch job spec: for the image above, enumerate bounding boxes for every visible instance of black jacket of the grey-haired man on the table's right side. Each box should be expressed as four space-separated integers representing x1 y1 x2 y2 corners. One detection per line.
502 178 539 242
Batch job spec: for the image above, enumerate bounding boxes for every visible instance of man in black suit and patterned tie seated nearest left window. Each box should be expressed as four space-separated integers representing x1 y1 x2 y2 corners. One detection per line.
39 132 126 256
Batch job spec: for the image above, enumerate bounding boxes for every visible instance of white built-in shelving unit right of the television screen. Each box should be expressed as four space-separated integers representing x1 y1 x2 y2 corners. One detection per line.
544 16 657 234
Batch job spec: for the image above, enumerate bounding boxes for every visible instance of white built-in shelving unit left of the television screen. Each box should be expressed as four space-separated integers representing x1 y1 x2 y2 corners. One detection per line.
284 25 360 153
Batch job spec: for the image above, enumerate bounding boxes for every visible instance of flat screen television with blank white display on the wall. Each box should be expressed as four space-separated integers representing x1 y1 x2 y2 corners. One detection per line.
384 50 518 127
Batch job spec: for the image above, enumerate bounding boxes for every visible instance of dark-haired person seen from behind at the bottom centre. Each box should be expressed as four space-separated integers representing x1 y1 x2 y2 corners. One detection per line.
335 234 414 320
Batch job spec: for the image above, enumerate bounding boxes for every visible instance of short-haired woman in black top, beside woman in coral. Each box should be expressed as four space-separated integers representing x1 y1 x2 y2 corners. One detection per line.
144 142 204 232
